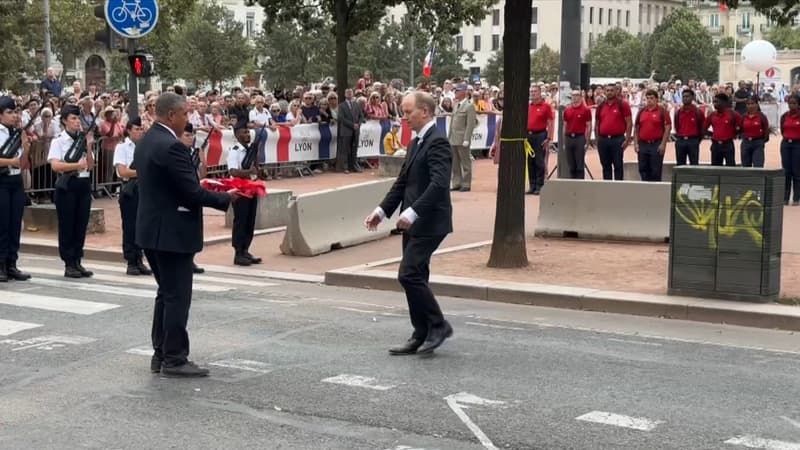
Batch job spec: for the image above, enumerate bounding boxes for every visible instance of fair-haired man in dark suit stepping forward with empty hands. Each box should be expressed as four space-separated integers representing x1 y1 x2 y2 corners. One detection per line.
364 92 453 355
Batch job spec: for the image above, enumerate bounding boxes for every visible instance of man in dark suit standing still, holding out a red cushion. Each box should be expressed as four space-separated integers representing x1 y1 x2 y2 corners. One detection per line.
132 92 237 377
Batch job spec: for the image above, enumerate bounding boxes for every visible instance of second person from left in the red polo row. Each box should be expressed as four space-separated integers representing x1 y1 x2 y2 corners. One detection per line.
561 91 592 180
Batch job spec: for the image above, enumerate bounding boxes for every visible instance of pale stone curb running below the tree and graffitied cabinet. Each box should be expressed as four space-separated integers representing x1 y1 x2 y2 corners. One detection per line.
325 266 800 331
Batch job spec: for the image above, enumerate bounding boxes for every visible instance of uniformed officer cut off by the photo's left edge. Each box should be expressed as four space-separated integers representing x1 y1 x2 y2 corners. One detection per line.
0 97 31 282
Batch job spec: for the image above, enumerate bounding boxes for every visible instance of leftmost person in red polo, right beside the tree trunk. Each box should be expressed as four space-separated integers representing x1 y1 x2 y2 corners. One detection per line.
527 85 555 195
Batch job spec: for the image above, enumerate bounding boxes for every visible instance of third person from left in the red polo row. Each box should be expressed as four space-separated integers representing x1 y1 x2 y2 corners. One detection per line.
594 83 633 180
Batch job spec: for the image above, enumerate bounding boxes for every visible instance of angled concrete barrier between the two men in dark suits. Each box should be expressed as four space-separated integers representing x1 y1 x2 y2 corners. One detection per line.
281 179 395 256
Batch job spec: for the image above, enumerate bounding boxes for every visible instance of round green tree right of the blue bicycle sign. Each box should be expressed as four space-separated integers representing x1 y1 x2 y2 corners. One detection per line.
172 3 253 85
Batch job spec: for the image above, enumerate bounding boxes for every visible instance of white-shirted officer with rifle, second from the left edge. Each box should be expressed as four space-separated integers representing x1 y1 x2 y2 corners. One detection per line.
47 105 94 278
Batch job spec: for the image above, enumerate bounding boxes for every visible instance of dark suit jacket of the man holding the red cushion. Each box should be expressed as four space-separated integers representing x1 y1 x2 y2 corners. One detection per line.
132 123 230 253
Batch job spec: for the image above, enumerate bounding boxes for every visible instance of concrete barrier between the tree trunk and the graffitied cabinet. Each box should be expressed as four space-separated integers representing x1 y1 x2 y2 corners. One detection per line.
535 180 671 242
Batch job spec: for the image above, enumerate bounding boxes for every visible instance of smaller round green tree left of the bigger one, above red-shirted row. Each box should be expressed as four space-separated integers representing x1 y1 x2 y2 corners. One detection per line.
586 28 649 78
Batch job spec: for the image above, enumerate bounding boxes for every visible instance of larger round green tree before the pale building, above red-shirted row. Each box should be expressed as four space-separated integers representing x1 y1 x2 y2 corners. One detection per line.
650 8 719 81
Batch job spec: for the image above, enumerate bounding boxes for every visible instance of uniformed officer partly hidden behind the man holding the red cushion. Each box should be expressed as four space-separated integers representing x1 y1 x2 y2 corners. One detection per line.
114 117 153 275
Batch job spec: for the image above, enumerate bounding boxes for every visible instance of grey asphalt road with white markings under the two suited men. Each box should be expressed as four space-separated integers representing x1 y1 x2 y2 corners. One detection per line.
0 257 800 450
